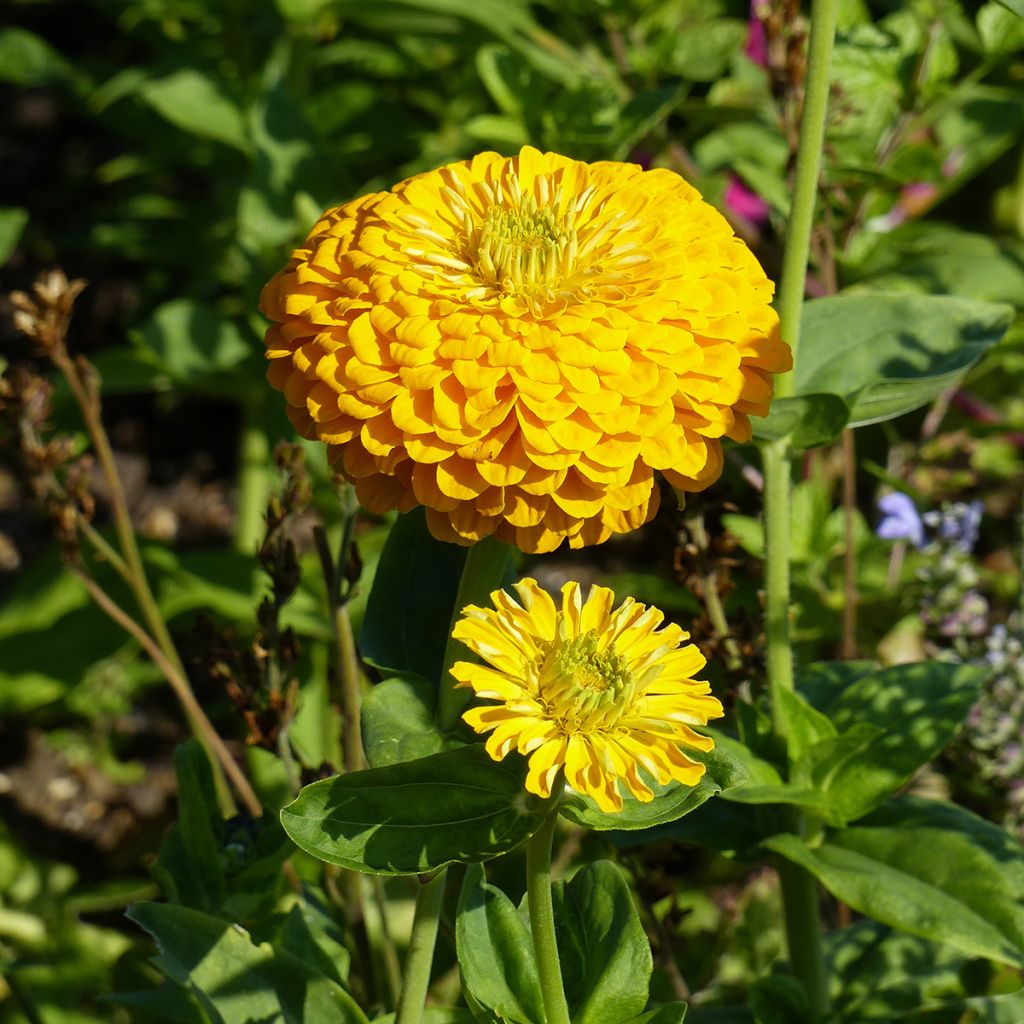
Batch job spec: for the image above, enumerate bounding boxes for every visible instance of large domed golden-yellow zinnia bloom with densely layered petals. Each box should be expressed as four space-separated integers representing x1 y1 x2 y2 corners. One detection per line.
261 146 791 552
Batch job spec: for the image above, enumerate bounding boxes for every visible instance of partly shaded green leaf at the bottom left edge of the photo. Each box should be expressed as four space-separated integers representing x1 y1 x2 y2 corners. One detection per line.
128 903 367 1024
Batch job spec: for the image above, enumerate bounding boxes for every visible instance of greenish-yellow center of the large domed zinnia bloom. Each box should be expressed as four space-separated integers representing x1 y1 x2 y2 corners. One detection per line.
467 196 578 295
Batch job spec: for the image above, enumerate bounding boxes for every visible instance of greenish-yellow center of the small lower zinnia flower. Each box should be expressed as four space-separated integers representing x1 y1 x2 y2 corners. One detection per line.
537 630 636 733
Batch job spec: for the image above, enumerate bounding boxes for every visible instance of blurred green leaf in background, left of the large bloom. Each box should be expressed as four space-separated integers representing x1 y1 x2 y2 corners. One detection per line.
133 299 255 382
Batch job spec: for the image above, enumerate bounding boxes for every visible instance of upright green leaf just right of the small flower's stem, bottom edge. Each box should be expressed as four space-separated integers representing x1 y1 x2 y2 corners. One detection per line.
557 860 653 1024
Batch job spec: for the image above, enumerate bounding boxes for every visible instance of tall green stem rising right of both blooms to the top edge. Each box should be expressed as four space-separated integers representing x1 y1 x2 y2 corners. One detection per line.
764 0 839 1018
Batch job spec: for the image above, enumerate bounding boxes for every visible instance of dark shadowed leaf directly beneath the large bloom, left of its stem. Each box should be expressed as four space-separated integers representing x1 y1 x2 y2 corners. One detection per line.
359 508 466 685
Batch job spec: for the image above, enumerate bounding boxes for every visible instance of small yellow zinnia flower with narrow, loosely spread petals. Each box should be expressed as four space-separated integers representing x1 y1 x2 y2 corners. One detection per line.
452 580 722 811
